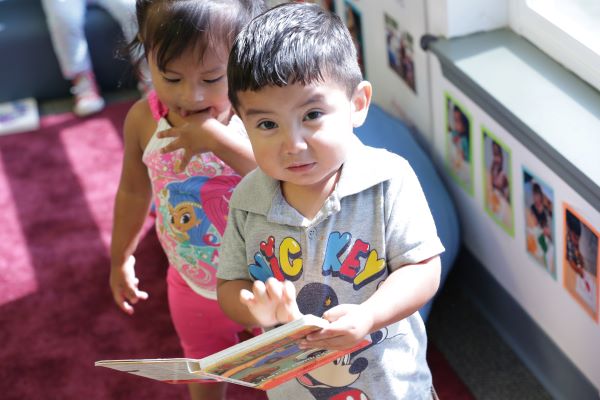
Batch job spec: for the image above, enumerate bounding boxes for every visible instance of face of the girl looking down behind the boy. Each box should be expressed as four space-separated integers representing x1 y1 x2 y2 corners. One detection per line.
148 44 231 125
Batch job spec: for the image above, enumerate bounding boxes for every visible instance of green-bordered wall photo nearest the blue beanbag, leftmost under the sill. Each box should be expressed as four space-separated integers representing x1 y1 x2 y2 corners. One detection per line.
444 92 474 196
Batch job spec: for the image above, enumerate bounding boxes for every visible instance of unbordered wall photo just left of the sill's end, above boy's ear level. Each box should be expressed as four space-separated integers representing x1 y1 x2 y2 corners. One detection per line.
383 13 417 93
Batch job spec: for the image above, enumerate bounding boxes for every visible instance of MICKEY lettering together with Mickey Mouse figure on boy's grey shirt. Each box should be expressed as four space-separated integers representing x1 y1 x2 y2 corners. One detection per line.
248 231 394 400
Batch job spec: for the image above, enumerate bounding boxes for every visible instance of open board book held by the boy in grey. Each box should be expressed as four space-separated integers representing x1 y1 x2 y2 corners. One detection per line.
94 314 371 390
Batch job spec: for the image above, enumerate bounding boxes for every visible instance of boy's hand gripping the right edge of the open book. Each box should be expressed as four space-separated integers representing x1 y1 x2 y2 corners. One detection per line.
300 304 373 350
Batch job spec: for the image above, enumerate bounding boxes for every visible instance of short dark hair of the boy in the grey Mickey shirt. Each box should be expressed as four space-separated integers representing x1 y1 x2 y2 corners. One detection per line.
227 3 363 109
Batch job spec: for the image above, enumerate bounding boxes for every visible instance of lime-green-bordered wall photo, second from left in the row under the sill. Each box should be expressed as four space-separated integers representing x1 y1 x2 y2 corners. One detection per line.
481 126 515 237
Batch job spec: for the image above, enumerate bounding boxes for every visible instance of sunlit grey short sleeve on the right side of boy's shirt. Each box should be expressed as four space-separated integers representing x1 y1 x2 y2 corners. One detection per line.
384 161 444 270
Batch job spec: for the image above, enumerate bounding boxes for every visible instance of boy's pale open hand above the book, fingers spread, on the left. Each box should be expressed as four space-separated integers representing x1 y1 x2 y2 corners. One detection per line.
240 278 302 327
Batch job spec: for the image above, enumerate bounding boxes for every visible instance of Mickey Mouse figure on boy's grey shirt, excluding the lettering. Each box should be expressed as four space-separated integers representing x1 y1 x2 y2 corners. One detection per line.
296 282 386 400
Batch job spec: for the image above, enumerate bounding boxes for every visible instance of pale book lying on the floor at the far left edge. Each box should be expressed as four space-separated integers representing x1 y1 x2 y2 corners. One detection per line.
0 97 40 135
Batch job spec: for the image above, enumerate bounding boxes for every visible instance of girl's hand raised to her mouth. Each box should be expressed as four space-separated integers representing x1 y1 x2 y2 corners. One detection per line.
158 111 224 172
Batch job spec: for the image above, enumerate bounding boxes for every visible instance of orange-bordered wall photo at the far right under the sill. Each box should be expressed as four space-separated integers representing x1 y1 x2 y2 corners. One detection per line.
563 203 600 322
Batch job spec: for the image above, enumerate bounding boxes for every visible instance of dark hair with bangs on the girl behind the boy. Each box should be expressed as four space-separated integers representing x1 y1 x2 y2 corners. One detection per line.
128 0 266 75
